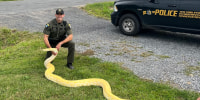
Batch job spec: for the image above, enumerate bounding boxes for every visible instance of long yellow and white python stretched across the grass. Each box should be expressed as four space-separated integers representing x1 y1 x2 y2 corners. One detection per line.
43 48 124 100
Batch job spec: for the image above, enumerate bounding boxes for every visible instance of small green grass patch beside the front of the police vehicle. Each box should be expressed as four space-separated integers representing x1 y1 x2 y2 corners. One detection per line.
83 2 114 20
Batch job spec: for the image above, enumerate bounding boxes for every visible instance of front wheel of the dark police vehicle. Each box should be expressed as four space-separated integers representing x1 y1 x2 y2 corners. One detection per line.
119 14 140 36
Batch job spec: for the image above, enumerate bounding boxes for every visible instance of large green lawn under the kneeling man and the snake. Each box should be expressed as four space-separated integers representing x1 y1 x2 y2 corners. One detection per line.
0 28 200 100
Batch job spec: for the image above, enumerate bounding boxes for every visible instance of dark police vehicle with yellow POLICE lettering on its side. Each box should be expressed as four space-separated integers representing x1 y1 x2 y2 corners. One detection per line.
111 0 200 35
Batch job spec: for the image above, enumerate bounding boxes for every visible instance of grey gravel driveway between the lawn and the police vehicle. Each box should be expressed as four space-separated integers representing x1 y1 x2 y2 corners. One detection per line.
0 0 200 92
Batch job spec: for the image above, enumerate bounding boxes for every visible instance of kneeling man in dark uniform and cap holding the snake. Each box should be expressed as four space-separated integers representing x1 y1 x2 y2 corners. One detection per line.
43 8 75 69
